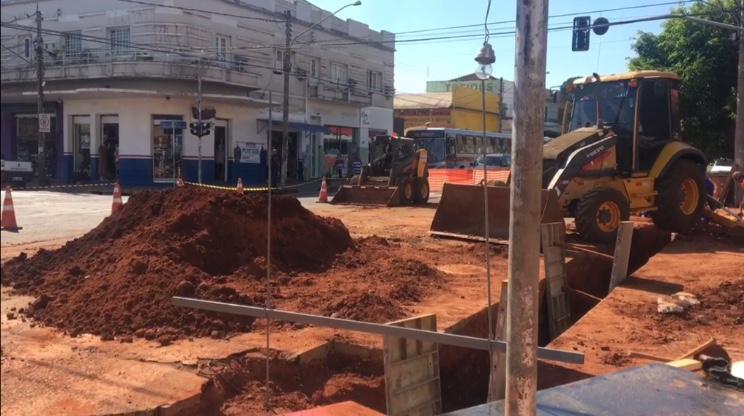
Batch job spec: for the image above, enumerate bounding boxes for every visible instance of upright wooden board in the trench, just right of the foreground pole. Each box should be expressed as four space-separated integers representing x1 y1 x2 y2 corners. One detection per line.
542 222 571 339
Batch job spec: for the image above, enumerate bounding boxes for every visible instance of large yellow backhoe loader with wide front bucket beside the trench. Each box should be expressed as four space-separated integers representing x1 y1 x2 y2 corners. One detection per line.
430 71 707 242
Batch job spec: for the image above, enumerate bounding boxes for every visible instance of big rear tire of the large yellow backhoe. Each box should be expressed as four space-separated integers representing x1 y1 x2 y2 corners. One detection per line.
651 159 707 233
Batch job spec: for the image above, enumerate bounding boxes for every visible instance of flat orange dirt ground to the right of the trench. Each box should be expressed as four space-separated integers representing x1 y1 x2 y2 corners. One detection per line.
542 235 744 386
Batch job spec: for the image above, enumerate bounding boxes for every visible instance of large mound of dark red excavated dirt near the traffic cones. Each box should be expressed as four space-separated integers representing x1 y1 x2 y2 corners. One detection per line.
1 187 354 344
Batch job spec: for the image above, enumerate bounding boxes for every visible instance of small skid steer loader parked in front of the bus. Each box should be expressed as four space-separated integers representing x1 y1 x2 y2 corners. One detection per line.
330 136 429 207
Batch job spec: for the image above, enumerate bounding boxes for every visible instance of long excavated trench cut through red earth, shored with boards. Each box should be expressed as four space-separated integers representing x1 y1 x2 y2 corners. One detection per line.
129 225 671 416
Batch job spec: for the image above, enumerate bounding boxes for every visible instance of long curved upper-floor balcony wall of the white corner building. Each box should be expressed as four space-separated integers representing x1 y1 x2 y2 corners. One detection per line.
0 50 261 89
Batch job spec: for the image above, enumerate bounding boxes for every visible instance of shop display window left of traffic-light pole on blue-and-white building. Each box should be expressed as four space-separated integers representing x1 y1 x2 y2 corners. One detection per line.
152 115 183 182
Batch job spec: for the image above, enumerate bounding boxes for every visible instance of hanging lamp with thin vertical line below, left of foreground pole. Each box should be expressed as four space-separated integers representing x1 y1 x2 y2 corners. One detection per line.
475 40 494 398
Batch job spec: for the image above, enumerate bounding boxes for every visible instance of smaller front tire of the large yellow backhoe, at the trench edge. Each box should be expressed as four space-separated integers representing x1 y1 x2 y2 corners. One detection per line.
575 188 630 243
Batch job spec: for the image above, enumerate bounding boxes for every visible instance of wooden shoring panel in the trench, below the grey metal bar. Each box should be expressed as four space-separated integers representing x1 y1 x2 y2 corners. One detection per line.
383 314 442 416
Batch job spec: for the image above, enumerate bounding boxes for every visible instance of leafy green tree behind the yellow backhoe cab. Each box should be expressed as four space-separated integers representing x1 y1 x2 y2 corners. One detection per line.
628 0 739 158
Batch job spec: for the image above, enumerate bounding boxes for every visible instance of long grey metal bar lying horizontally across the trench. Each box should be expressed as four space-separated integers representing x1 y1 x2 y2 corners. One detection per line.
172 296 584 364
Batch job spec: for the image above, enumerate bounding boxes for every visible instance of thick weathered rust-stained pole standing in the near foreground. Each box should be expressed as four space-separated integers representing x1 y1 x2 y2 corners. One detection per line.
506 0 548 415
